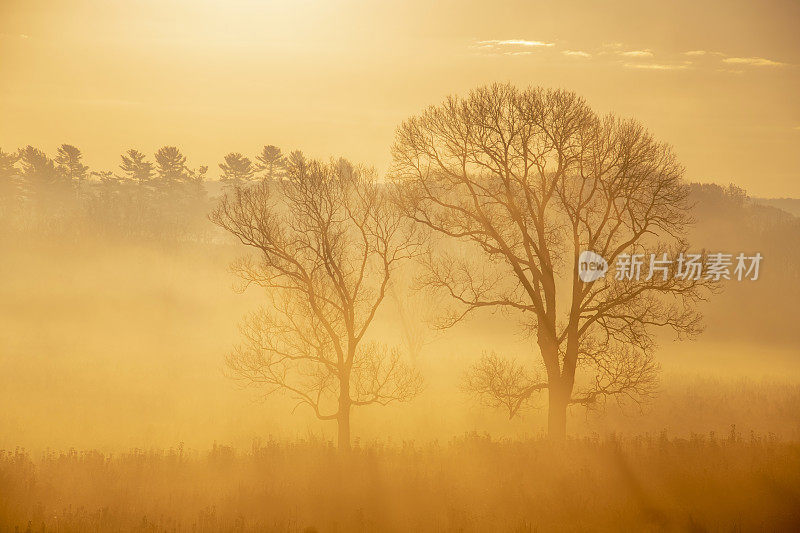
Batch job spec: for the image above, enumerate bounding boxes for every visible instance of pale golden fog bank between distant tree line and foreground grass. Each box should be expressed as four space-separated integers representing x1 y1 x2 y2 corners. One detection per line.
0 184 800 452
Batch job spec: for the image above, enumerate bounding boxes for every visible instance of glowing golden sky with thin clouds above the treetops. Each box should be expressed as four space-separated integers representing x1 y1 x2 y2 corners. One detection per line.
0 0 800 197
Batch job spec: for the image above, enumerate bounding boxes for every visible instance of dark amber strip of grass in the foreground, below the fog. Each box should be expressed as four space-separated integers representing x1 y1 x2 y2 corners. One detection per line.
0 430 800 532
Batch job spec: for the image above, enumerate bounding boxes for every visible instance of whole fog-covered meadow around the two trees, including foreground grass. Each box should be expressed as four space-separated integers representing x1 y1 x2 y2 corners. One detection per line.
0 186 800 532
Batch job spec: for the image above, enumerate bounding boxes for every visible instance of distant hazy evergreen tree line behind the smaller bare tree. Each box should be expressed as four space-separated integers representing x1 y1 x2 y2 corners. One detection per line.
0 144 296 240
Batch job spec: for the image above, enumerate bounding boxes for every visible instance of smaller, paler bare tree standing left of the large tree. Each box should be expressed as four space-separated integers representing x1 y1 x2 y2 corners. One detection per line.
211 156 421 449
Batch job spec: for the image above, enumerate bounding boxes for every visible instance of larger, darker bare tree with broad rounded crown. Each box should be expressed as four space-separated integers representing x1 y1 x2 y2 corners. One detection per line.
393 85 707 439
